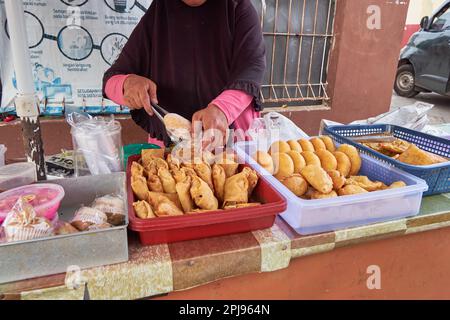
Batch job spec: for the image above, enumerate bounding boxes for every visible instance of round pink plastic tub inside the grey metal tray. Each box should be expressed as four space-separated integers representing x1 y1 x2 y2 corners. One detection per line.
0 184 65 223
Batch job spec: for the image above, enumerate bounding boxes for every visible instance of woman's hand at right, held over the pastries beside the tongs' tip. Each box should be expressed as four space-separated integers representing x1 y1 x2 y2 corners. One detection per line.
192 104 228 147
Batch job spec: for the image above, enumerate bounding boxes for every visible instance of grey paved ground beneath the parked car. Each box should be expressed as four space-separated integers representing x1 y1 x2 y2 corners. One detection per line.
391 93 450 124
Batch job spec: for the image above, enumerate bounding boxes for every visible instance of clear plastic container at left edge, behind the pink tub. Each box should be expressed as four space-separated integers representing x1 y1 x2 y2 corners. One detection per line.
0 162 37 192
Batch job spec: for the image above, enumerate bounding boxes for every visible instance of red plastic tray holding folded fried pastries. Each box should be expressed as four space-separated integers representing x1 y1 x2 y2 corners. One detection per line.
127 155 287 245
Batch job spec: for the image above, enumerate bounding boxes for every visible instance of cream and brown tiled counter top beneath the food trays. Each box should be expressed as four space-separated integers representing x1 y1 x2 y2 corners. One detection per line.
0 194 450 299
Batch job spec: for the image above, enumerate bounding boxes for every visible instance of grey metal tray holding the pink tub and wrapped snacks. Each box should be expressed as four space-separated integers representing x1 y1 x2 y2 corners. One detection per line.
0 173 128 283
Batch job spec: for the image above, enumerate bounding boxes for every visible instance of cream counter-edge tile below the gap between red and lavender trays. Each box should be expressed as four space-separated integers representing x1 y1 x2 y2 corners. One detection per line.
253 224 291 272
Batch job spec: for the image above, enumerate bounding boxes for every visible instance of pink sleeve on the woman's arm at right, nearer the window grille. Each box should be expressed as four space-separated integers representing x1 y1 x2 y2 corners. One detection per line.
212 90 253 125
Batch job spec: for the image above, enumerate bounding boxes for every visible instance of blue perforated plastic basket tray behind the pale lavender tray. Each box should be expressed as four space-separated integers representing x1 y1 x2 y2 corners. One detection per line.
325 124 450 196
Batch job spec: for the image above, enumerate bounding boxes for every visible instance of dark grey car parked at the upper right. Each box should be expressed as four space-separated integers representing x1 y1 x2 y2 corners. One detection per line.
394 0 450 98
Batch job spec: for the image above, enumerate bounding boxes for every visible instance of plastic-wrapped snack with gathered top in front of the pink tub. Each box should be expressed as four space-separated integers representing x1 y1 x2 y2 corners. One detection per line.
3 197 54 242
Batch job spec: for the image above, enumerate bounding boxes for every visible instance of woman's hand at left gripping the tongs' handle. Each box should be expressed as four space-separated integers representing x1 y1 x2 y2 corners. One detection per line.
123 74 158 116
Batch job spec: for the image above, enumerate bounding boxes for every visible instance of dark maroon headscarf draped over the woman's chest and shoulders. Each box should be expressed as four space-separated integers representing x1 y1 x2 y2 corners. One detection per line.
103 0 265 140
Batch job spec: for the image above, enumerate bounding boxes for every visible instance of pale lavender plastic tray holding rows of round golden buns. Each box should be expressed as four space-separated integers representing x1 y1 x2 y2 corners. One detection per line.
235 142 428 235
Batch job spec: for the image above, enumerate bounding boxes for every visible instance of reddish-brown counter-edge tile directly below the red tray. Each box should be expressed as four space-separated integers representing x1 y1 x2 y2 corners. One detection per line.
169 233 261 290
